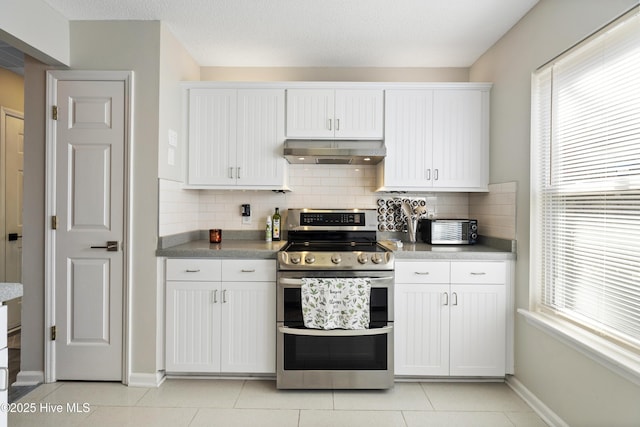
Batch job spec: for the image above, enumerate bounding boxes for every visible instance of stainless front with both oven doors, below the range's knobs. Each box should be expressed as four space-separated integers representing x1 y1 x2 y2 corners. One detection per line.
276 271 394 389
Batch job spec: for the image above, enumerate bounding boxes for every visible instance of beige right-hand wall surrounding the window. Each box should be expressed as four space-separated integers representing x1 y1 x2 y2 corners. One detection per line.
470 0 640 426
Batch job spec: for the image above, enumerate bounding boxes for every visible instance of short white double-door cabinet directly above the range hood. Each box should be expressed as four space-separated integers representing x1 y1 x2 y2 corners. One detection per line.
286 89 384 139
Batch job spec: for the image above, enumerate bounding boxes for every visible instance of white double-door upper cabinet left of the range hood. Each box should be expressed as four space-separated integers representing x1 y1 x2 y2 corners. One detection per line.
187 88 287 189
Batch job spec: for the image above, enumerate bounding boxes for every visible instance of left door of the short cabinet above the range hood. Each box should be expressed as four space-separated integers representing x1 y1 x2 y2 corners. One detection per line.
287 89 335 139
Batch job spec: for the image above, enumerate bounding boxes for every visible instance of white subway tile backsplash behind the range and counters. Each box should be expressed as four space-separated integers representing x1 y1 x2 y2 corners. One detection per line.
158 165 515 241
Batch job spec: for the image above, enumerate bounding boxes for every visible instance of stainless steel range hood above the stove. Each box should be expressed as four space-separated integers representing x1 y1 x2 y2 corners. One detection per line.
284 139 387 165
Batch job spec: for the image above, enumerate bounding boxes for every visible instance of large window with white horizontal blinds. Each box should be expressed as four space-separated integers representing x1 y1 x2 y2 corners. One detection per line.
531 10 640 351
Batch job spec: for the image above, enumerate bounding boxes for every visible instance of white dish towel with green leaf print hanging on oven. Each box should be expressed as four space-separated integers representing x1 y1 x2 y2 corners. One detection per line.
301 278 371 330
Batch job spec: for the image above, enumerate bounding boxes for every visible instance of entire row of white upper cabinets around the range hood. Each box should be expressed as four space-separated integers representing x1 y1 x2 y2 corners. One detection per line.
184 82 491 192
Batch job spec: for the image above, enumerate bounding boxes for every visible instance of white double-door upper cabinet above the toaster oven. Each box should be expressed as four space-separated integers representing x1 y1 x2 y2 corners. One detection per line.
378 86 489 191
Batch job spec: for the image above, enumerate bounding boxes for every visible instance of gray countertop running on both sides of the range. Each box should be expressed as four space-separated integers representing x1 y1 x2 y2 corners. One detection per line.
156 240 516 260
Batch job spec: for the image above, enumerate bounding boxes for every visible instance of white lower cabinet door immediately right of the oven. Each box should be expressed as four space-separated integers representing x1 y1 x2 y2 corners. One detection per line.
394 283 450 376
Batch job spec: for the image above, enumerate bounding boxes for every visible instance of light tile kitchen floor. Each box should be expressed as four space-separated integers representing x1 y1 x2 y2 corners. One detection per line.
9 379 546 427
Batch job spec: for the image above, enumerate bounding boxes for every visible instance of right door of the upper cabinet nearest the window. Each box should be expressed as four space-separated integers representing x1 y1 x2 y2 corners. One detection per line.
433 90 489 189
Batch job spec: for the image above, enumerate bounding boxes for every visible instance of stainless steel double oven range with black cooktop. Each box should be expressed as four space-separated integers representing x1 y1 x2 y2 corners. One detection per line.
276 209 394 389
